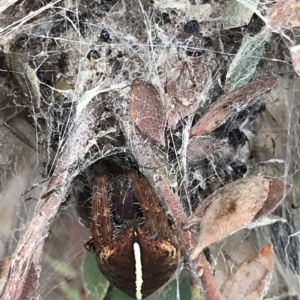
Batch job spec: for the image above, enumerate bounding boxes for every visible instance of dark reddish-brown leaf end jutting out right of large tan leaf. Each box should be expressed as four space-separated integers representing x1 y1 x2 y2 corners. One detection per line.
252 178 291 221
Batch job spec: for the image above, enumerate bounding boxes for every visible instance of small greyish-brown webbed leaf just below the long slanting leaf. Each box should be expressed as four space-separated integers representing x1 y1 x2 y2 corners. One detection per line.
186 136 224 161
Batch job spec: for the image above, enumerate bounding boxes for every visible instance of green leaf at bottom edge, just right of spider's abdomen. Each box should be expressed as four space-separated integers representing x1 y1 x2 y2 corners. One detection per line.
159 277 192 300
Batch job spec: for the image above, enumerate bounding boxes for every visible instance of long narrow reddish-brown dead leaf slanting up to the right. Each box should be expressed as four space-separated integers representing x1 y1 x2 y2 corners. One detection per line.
190 77 276 136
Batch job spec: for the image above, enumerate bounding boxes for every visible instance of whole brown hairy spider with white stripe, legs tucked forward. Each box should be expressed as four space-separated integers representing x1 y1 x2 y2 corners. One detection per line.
85 171 180 299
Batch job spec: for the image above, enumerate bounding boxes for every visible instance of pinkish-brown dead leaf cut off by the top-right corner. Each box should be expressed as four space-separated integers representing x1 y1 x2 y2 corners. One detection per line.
268 0 300 30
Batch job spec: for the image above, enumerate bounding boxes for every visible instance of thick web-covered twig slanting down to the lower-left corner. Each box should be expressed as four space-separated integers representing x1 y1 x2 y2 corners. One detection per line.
0 102 101 300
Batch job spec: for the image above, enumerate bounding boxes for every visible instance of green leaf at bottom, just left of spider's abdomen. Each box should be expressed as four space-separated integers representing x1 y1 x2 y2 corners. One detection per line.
82 252 109 300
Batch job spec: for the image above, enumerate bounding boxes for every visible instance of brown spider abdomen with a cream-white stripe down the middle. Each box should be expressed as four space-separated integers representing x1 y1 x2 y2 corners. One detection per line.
96 227 179 299
